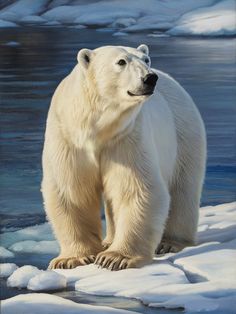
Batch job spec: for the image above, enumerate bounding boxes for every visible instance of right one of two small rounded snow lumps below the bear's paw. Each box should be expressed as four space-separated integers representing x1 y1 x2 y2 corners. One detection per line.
27 270 67 291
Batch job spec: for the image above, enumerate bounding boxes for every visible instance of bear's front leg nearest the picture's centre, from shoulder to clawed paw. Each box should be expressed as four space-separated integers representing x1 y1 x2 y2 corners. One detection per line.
95 145 169 270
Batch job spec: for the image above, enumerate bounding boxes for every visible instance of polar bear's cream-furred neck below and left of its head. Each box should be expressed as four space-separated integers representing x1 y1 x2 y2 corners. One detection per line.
62 67 141 152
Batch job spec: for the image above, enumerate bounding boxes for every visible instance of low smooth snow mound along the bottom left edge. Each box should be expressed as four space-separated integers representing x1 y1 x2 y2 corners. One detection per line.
1 293 135 314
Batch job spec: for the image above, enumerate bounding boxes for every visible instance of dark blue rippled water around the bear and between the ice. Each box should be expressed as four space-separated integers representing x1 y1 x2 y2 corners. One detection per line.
0 28 236 314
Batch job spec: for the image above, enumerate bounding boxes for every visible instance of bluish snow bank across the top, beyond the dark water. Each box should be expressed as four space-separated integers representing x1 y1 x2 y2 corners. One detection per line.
0 0 236 36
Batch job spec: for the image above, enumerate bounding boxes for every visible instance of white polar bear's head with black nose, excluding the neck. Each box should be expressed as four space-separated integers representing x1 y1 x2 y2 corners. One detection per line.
78 45 158 106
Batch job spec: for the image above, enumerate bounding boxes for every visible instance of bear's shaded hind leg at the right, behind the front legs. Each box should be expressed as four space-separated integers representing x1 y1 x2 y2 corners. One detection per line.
156 154 205 254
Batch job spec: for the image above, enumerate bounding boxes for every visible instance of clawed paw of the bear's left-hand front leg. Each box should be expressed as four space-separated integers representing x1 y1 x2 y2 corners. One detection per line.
48 255 95 269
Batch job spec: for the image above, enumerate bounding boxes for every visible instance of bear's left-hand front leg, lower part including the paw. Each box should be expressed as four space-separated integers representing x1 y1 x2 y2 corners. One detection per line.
42 179 102 269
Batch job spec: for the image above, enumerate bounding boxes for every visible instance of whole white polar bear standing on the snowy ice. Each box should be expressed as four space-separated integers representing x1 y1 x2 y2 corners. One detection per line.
42 44 206 270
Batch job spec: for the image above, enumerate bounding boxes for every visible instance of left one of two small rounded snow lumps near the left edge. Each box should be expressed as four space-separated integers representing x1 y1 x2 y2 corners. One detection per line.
7 265 42 288
